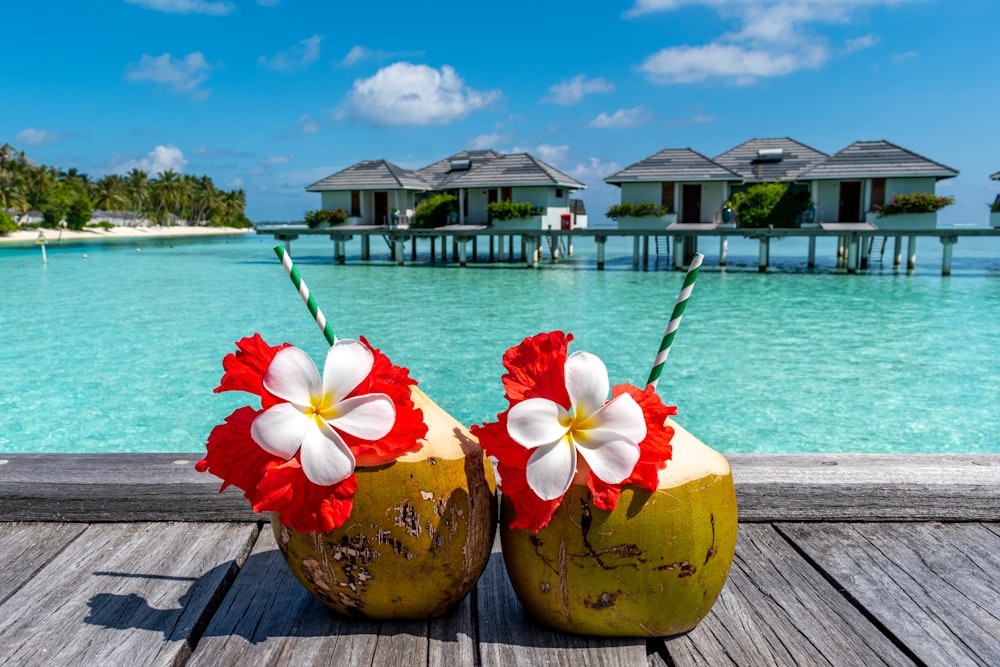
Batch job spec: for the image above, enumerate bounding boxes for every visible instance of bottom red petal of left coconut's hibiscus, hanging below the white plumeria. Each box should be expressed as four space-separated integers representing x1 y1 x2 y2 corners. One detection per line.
253 457 358 533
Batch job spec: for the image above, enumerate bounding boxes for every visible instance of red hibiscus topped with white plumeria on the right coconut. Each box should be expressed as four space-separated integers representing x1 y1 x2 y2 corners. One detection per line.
472 331 677 532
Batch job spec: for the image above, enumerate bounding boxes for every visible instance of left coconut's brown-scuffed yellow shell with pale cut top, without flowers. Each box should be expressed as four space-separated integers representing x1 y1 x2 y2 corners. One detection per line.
271 388 497 620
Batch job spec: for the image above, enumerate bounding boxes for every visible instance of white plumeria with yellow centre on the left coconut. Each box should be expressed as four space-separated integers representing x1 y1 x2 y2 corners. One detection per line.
250 340 396 486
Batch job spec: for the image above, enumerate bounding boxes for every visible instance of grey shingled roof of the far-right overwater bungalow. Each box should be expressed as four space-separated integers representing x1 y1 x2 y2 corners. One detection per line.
803 141 958 180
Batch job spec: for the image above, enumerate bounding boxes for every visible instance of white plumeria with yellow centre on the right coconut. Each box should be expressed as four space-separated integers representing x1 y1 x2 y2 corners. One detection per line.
507 352 646 500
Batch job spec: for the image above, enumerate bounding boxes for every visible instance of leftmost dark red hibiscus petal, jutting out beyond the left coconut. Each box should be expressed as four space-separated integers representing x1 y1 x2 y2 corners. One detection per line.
195 406 281 504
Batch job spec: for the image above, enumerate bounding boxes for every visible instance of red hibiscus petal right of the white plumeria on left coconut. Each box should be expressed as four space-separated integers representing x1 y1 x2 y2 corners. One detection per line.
338 336 427 467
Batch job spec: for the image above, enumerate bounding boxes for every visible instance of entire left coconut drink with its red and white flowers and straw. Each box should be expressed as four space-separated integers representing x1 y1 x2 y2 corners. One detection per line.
197 246 497 620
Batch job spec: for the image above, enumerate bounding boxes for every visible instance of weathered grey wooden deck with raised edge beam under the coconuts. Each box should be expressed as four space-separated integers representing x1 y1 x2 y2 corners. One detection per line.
0 454 1000 667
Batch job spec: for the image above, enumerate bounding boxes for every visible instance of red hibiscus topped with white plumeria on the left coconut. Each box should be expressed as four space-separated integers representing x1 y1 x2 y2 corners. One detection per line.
196 334 427 532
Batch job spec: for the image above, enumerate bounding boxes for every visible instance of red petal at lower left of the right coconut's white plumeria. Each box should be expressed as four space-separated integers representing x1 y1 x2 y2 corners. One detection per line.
471 412 562 533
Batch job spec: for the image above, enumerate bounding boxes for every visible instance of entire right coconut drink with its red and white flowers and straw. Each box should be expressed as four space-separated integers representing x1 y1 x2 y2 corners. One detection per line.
472 255 737 636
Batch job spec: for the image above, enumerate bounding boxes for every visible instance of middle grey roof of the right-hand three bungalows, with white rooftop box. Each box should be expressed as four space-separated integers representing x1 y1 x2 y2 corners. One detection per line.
715 137 827 183
